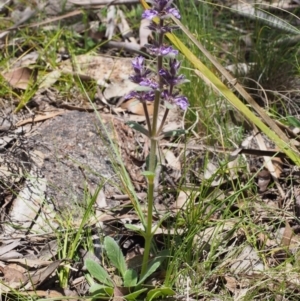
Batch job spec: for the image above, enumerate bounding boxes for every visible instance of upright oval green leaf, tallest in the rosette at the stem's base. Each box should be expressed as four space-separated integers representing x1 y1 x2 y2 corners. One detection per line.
104 236 127 278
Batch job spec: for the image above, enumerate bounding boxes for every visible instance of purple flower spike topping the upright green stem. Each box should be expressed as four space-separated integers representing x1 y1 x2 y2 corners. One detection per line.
125 0 189 110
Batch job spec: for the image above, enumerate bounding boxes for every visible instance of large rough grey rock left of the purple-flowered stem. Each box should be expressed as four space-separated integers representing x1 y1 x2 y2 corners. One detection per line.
32 111 114 211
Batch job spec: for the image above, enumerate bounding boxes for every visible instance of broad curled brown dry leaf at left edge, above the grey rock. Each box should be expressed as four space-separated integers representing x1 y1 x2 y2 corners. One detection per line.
2 67 36 90
